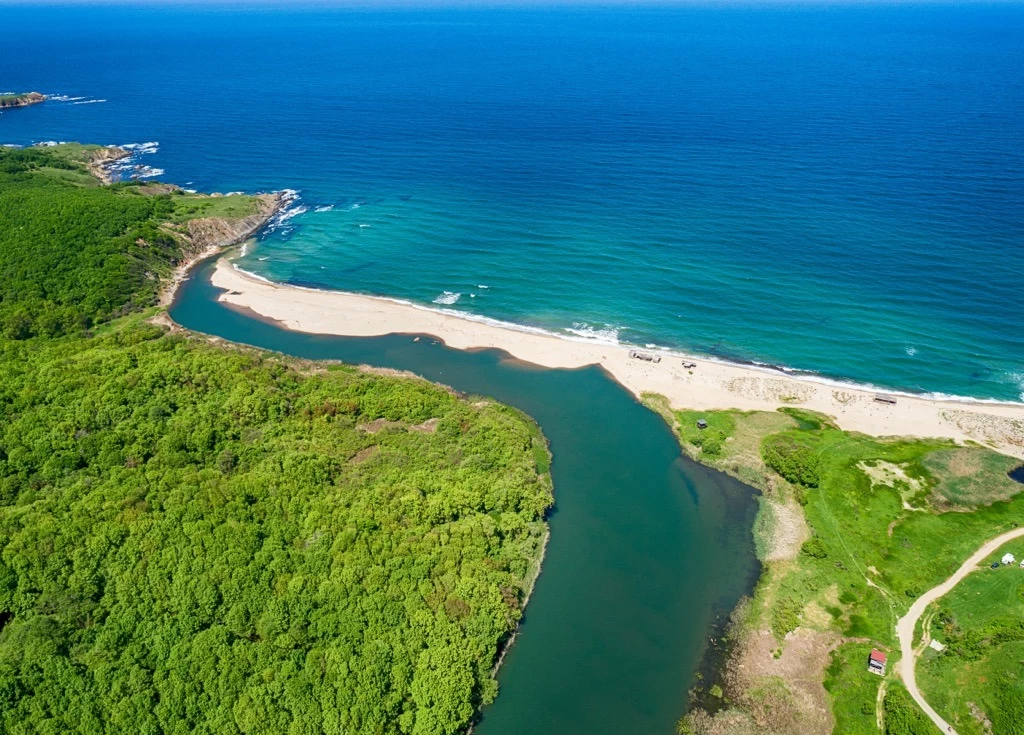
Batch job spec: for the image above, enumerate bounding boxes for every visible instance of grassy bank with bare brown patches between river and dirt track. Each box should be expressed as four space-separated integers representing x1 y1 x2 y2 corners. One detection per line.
647 396 1024 735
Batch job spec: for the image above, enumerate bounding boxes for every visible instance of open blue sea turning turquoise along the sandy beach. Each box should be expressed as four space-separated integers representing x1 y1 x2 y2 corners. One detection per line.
0 4 1024 400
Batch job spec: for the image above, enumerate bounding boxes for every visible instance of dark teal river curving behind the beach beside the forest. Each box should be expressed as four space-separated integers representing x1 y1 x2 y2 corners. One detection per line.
171 258 760 735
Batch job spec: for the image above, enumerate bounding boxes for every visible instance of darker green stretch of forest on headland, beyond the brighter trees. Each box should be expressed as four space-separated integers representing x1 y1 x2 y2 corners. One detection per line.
0 148 186 339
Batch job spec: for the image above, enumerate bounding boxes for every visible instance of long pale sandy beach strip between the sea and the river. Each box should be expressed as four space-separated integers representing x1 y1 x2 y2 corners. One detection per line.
213 259 1024 459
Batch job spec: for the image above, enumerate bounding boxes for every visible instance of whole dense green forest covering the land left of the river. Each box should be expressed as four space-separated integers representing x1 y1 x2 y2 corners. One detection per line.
0 149 552 735
